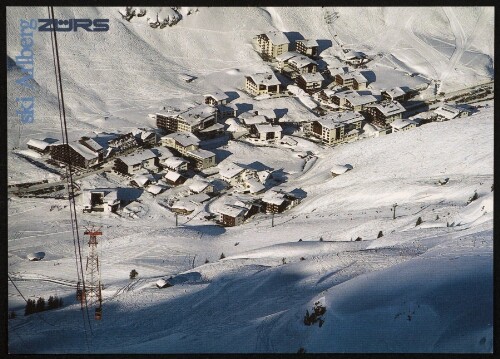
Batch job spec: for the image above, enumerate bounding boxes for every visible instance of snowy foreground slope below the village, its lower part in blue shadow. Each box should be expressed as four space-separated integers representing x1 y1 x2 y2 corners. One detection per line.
8 102 494 353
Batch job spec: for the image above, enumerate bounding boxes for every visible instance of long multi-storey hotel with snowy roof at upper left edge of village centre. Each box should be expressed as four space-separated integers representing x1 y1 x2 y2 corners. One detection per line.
156 104 217 134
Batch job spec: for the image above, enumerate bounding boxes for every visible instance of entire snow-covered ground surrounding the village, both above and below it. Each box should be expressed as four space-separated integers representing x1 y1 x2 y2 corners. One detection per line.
7 7 494 354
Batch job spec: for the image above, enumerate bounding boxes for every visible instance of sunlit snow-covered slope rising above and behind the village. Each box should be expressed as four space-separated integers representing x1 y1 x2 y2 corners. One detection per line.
7 7 494 148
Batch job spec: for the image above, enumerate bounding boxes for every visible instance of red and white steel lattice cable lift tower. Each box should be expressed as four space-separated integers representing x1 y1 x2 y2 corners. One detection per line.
84 226 102 319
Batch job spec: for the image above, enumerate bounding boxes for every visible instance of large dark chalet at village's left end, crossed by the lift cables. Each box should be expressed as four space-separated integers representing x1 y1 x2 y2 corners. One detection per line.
50 142 102 168
